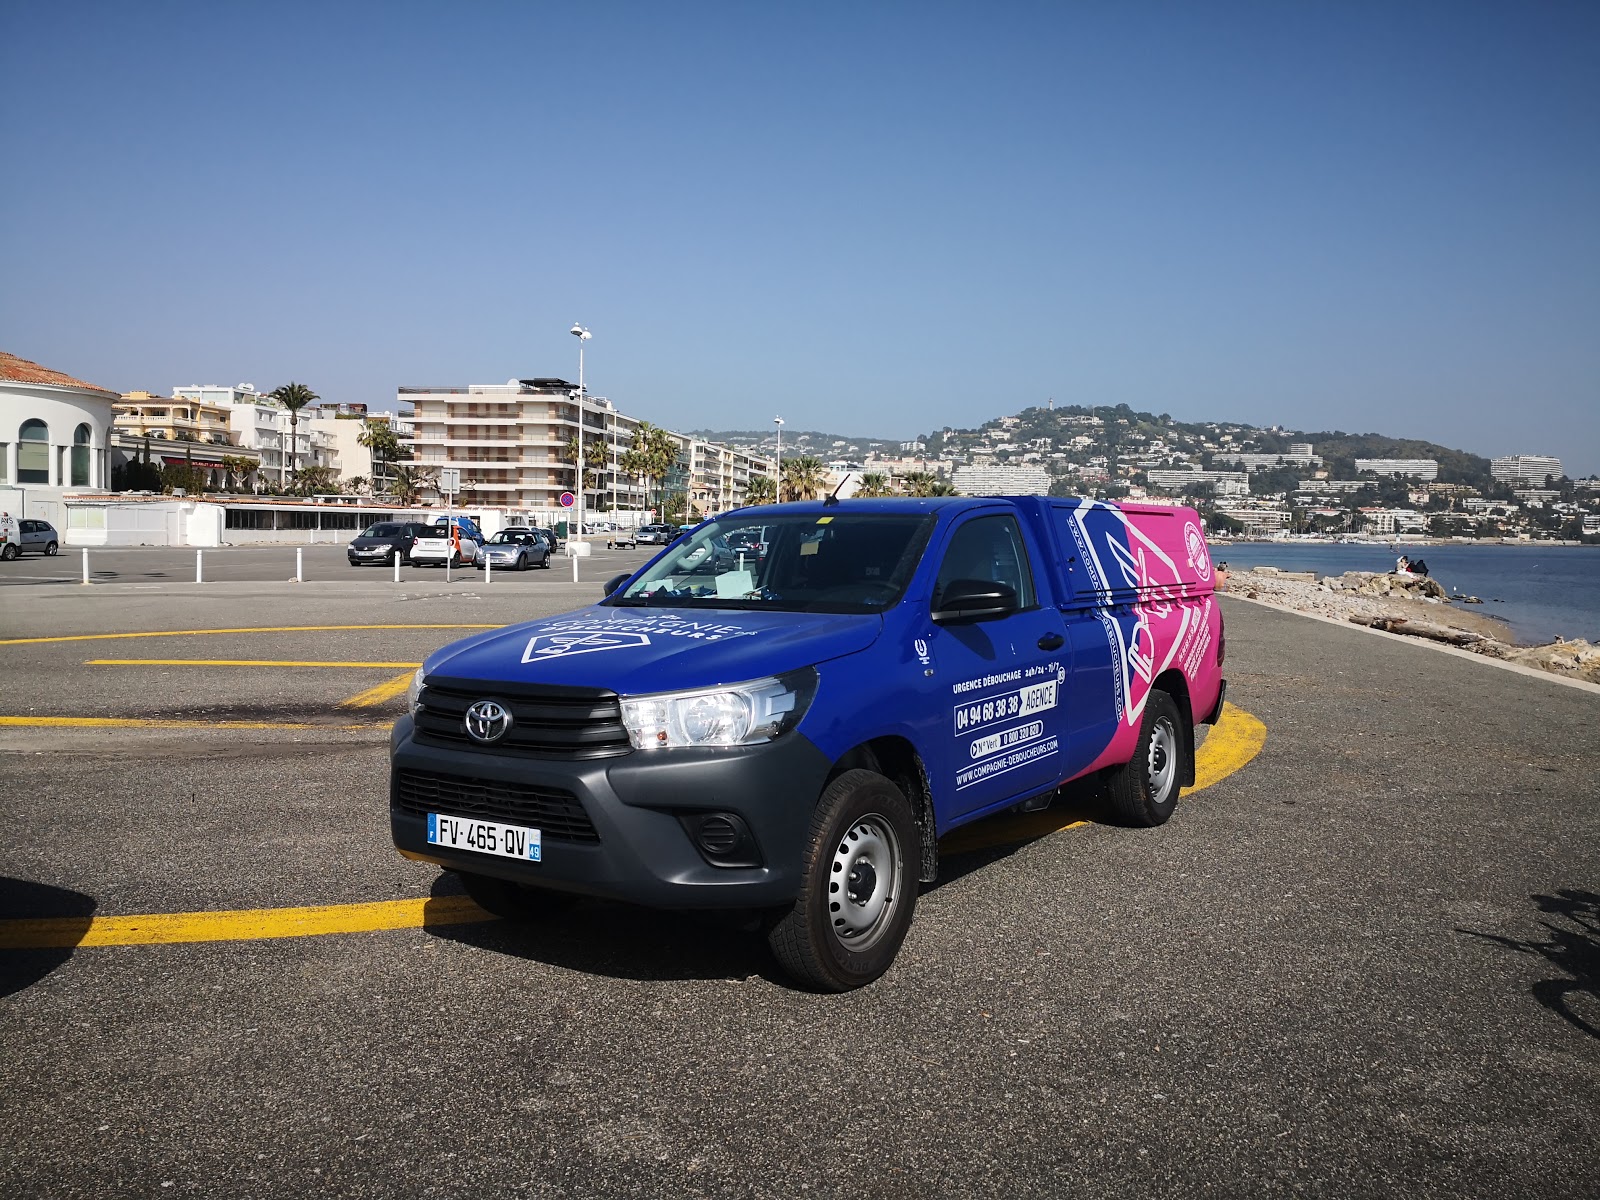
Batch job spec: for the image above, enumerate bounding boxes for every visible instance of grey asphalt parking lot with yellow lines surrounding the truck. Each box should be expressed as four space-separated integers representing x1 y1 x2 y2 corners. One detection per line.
0 579 1600 1197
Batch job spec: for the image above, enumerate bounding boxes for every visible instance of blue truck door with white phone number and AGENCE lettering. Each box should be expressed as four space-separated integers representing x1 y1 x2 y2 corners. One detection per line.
930 514 1067 824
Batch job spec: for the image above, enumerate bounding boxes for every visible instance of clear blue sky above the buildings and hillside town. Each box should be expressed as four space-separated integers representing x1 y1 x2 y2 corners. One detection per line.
0 0 1600 474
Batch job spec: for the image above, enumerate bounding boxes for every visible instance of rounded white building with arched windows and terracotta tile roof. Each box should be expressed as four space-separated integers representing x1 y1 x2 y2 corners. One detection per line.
0 352 118 530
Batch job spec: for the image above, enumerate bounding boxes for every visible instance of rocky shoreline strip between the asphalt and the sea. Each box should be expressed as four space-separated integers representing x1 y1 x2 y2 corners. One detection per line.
1222 566 1600 683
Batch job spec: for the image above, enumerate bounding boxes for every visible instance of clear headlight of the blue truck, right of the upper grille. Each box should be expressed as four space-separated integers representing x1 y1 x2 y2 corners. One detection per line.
622 670 816 750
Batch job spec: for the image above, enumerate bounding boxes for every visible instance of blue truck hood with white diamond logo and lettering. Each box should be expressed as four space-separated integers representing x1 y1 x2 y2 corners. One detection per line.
424 605 883 696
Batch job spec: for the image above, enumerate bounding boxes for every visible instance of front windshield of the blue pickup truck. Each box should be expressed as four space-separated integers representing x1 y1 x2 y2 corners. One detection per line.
608 506 934 613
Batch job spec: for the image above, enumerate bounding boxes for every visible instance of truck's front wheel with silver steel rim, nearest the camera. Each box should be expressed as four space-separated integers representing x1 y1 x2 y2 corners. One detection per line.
768 771 922 992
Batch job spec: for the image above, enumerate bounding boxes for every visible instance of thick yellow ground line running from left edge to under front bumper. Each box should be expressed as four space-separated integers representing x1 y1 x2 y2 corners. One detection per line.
0 896 494 950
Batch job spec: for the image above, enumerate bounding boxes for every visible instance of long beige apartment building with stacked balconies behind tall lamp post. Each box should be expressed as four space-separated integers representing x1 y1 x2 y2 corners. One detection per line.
398 378 773 512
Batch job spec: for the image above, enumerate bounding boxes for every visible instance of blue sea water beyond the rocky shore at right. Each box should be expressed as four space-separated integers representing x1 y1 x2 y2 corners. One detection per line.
1211 542 1600 645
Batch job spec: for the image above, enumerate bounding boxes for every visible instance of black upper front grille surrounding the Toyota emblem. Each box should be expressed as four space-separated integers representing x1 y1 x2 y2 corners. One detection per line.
416 677 634 758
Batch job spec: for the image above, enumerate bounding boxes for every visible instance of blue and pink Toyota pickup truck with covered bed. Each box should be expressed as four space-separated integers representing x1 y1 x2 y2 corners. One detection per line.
390 496 1224 990
